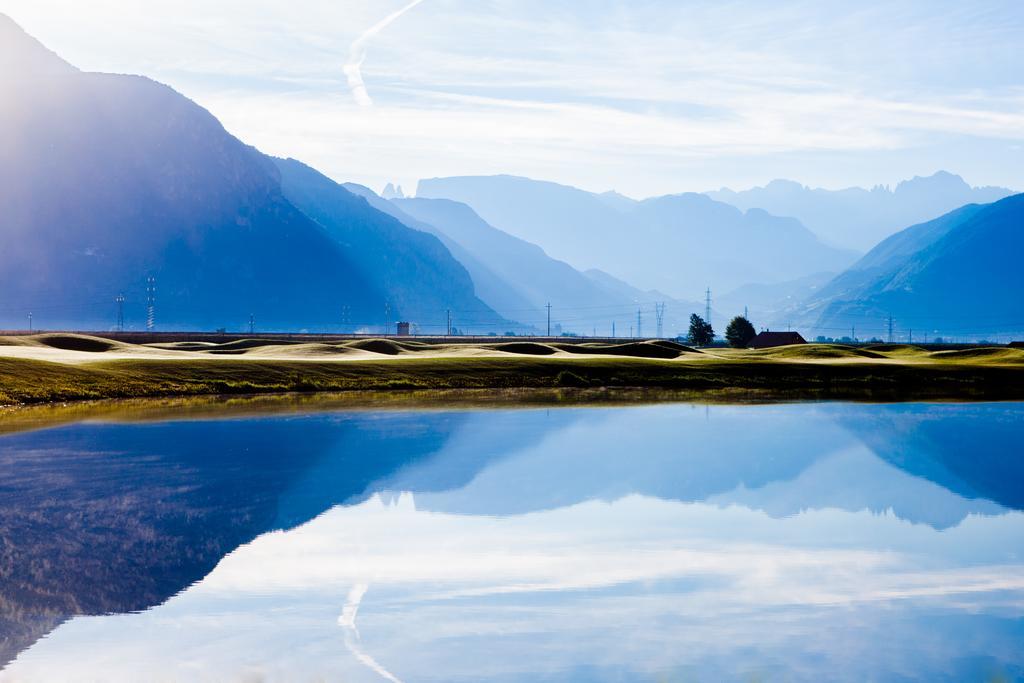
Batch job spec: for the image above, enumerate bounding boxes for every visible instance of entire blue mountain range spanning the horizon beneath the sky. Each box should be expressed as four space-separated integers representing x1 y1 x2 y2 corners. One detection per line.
0 15 1024 339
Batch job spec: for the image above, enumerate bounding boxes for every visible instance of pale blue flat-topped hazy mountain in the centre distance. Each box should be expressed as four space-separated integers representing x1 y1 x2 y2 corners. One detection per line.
417 176 856 299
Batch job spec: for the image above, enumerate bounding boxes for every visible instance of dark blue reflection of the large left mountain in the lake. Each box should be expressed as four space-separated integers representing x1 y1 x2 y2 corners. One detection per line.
0 413 464 666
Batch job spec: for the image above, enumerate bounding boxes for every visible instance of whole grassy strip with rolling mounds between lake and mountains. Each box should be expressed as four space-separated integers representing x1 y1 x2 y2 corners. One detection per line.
0 335 1024 404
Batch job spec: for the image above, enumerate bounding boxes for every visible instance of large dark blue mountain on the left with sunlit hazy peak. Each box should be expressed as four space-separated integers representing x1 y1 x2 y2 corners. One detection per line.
0 15 497 330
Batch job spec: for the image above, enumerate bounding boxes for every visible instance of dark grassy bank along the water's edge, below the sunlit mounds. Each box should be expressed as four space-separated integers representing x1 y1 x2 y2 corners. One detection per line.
0 349 1024 404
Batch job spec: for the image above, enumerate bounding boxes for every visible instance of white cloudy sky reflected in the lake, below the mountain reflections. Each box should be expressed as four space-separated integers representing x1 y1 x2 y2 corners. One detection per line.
10 495 1024 681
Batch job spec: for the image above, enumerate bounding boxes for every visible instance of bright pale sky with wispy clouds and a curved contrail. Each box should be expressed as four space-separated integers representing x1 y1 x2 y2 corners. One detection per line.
0 0 1024 198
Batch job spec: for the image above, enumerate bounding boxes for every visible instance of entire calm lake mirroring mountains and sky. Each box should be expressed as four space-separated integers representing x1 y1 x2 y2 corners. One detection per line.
0 403 1024 683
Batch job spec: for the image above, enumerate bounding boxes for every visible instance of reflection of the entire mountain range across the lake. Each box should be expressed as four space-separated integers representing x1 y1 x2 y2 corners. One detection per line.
0 404 1024 664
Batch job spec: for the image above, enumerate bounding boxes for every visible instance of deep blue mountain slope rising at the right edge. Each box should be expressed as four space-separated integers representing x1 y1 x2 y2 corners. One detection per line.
801 195 1024 340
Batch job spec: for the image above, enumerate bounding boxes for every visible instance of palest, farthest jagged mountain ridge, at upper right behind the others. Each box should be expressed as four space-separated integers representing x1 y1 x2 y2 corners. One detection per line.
707 171 1013 250
